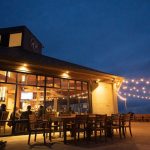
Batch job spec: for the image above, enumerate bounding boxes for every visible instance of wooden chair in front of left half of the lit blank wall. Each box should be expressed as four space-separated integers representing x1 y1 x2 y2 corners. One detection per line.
94 115 108 142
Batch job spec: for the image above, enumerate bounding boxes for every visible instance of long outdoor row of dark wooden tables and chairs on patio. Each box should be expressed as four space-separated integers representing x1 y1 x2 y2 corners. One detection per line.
28 114 132 145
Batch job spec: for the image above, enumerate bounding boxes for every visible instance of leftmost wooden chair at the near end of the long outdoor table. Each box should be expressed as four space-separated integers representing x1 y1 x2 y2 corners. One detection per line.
28 114 50 144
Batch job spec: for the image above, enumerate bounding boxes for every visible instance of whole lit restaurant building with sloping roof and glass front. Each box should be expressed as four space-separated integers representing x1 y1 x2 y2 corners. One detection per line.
0 26 123 136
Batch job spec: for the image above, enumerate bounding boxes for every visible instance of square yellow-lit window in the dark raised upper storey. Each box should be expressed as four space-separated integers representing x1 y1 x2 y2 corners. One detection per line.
9 33 22 47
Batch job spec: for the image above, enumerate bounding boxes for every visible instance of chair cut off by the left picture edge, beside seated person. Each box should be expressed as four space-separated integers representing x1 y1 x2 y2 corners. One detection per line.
0 111 9 133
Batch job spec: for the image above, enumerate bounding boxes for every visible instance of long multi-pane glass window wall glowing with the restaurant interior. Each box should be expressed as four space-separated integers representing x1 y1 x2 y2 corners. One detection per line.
0 71 89 135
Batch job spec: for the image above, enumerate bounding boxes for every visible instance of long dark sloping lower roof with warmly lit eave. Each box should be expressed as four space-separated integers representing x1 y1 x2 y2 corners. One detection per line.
0 48 123 80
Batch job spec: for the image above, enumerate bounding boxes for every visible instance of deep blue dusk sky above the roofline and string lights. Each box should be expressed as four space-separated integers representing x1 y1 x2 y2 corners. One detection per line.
0 0 150 112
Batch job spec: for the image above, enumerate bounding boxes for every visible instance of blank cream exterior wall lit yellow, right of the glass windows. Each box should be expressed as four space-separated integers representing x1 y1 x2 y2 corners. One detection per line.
92 82 118 115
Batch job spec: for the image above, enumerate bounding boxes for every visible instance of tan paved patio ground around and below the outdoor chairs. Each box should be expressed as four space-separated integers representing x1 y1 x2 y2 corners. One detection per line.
2 122 150 150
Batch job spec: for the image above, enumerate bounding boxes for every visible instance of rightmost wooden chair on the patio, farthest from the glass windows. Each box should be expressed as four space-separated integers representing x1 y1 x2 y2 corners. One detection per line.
122 114 132 137
